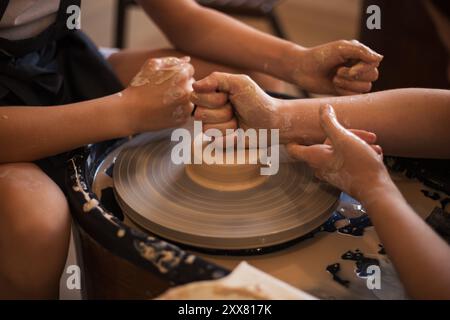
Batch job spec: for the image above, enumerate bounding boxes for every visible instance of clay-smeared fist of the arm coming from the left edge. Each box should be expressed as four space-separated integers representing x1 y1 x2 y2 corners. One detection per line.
122 57 194 133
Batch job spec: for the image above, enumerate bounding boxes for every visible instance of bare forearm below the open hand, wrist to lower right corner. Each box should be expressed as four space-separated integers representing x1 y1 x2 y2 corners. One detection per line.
363 183 450 299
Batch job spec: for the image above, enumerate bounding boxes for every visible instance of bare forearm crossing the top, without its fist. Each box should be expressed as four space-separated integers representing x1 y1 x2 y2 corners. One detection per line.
139 0 301 78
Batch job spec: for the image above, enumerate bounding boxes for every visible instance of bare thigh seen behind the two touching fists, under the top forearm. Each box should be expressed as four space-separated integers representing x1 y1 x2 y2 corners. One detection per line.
108 49 285 92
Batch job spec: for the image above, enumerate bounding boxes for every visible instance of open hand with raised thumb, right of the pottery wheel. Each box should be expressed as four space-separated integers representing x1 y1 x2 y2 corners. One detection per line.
287 105 391 201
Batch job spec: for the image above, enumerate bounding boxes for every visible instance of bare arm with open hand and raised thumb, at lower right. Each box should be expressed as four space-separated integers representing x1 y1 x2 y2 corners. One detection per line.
287 105 450 299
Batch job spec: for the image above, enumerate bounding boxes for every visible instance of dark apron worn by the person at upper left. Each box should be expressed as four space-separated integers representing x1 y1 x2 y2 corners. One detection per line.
0 0 123 187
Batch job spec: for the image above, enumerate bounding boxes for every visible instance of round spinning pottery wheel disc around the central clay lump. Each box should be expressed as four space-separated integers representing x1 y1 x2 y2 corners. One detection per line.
113 134 339 250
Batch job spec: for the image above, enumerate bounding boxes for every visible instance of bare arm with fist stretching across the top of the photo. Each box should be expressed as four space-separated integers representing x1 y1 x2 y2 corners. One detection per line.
139 0 382 95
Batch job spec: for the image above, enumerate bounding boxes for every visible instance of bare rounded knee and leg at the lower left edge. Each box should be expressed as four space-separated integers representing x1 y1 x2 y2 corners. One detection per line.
0 163 70 299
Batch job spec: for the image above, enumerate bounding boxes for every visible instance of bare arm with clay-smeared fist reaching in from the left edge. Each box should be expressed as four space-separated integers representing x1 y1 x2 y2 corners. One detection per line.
0 58 194 163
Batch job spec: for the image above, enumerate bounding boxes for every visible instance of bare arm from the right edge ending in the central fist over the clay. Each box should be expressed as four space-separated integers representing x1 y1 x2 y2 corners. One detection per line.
192 73 450 158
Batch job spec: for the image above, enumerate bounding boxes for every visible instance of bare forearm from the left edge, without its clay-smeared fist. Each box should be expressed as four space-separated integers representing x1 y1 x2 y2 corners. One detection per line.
0 95 131 163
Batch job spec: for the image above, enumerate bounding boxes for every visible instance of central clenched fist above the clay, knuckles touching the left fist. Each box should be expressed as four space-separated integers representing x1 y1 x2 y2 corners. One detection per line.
191 72 278 133
